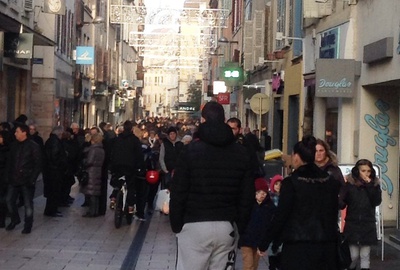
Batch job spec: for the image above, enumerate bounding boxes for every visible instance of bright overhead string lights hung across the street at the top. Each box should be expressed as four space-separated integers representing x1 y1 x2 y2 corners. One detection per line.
109 0 229 69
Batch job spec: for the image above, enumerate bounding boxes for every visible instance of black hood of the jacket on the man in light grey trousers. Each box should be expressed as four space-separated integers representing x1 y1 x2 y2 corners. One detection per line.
199 121 235 146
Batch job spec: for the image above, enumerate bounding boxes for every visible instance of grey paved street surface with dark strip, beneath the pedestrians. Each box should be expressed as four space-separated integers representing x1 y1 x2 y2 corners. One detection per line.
0 179 400 270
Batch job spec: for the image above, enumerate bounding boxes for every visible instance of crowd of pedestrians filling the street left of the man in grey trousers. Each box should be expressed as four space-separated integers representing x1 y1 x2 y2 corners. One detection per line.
0 115 200 233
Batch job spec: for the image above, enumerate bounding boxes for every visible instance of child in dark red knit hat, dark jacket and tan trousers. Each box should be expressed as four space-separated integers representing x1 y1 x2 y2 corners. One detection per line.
239 178 276 270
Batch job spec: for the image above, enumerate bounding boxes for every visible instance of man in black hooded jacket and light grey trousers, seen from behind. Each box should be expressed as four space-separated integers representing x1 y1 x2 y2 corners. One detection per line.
169 102 255 270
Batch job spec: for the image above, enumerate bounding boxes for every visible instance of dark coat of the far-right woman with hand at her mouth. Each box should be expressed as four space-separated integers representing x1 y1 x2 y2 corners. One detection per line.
339 175 382 245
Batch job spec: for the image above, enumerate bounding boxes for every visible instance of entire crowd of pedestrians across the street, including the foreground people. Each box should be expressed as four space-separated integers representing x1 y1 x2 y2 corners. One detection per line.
0 105 382 270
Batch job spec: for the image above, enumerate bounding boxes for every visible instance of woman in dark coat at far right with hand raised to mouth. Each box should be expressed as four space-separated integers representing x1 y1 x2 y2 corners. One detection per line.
339 159 382 270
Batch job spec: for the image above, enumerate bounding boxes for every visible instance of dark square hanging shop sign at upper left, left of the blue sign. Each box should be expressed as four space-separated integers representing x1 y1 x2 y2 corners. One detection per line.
4 32 33 59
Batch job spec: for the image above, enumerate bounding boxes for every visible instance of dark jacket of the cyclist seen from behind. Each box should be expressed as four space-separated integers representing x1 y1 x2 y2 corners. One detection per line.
110 131 144 175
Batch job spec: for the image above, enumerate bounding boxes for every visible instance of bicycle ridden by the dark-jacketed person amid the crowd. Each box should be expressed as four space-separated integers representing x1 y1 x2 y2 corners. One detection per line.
114 175 133 229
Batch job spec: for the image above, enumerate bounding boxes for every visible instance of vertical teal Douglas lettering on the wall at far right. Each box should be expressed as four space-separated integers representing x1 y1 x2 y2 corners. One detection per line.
364 99 396 196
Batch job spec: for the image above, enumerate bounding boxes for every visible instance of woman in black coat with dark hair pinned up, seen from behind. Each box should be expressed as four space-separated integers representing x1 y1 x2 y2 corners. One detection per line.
258 136 340 270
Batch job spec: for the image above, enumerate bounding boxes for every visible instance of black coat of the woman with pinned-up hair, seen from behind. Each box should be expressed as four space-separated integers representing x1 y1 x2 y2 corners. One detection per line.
259 163 340 251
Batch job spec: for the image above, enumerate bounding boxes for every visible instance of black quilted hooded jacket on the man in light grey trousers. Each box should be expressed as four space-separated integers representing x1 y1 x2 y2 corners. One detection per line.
169 122 255 233
